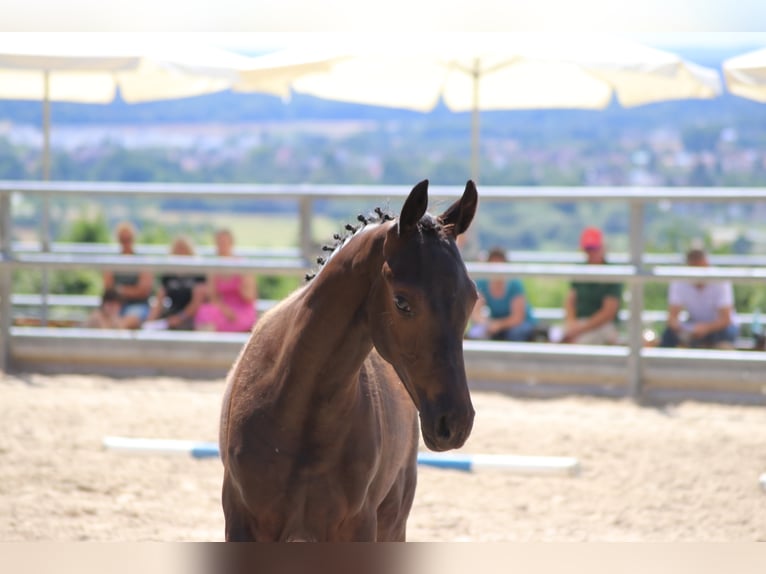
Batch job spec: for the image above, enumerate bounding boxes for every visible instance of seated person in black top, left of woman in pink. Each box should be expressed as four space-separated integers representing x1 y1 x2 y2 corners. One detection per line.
144 237 205 331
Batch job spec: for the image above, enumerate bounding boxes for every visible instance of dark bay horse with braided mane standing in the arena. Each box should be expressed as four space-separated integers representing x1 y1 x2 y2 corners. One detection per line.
220 181 478 541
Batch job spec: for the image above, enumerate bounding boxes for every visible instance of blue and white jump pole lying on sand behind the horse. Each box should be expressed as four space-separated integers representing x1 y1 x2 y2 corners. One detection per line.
103 436 580 475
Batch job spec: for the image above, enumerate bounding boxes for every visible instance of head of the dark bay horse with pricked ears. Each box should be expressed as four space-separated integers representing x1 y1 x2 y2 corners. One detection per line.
370 181 478 451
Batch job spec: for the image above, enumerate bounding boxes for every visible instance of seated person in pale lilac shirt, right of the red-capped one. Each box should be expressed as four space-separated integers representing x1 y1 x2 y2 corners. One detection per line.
660 249 739 349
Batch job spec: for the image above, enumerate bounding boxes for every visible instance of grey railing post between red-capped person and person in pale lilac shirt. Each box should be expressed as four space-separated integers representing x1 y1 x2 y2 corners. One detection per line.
628 201 644 399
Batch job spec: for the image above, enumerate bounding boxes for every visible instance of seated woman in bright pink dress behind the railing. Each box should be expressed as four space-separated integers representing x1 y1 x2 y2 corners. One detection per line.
195 229 257 332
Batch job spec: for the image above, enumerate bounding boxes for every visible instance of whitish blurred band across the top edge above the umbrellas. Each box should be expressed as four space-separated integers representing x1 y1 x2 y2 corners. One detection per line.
0 0 766 38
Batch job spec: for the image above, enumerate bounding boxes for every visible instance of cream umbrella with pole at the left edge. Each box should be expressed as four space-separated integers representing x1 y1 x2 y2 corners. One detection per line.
0 33 260 179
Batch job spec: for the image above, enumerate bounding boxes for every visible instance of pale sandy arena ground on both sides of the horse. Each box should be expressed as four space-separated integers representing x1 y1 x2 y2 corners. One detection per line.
0 375 766 541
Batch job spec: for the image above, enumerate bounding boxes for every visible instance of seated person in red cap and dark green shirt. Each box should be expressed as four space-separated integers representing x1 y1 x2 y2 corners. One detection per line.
562 227 622 345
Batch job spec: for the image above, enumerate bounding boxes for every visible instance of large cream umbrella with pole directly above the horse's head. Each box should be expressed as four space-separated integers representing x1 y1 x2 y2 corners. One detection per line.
233 35 721 178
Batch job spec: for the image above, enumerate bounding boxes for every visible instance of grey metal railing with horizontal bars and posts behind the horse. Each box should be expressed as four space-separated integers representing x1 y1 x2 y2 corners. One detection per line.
0 181 766 396
